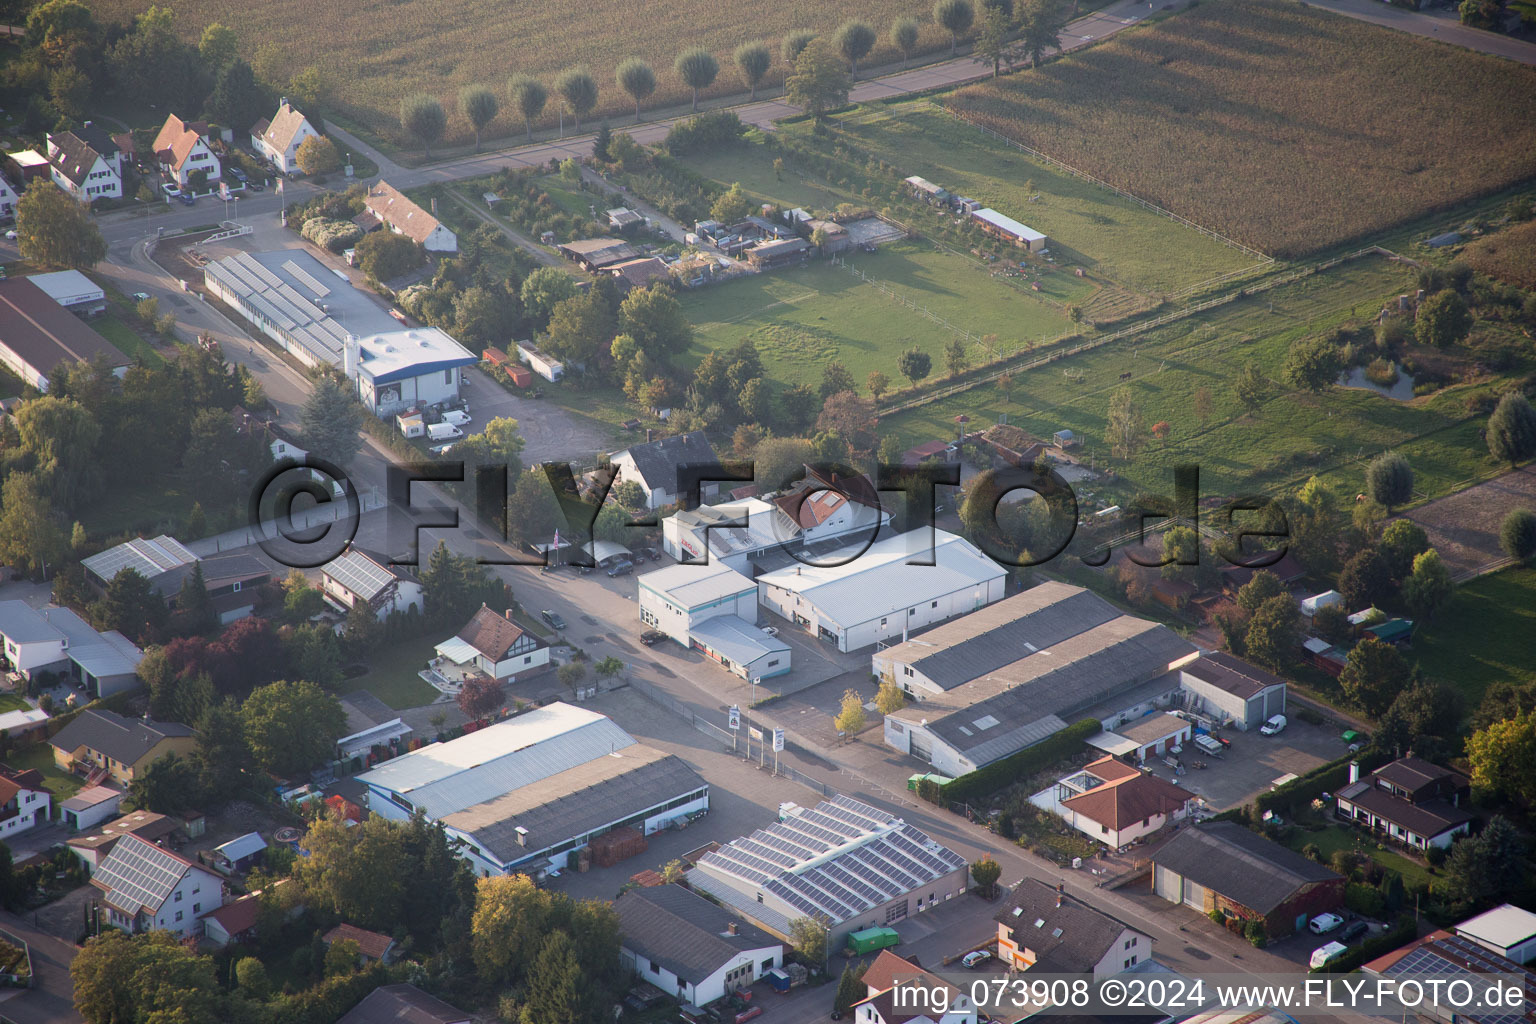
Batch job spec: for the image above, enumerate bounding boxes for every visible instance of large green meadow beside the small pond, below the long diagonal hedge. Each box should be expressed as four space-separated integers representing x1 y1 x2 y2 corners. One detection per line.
880 258 1517 496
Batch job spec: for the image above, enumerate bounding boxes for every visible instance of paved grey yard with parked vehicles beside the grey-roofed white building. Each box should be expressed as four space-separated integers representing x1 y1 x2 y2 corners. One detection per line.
1147 715 1346 811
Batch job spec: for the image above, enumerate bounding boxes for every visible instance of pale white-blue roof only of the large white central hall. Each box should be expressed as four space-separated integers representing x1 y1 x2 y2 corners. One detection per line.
757 530 1005 626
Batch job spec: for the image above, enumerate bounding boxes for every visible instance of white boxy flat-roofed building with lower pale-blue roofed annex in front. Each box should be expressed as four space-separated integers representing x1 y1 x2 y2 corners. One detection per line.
636 562 790 679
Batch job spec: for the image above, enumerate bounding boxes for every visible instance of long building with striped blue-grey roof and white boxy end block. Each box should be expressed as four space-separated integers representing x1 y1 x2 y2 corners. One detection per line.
203 249 478 419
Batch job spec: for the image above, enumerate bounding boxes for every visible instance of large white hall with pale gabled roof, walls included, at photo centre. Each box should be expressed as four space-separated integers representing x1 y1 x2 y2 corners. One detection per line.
757 530 1008 651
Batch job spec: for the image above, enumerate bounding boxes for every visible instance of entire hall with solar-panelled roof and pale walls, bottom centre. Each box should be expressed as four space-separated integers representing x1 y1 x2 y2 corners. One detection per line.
688 795 969 950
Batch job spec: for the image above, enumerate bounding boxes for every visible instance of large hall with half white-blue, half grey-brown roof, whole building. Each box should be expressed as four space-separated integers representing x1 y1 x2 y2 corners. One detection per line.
358 703 710 877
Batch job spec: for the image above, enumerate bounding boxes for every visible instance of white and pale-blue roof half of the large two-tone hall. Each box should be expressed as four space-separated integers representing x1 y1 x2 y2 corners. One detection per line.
358 703 634 818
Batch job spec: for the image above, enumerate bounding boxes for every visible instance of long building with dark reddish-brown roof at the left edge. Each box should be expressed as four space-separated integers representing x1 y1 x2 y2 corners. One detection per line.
0 278 132 391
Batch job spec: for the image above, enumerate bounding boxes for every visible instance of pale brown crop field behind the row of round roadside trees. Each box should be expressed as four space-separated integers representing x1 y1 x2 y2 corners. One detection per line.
88 0 949 149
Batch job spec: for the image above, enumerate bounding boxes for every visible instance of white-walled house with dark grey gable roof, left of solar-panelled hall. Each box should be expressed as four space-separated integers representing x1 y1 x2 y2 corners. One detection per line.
613 886 783 1006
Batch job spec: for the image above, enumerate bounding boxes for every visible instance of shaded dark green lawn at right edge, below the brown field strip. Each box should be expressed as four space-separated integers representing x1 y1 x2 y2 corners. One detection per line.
1413 568 1536 711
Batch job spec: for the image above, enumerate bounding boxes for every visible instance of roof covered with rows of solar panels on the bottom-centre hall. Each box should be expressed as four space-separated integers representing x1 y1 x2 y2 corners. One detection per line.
700 795 965 923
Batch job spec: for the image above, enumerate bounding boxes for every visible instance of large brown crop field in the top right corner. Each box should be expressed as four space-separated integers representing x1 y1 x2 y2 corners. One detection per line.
948 0 1536 258
